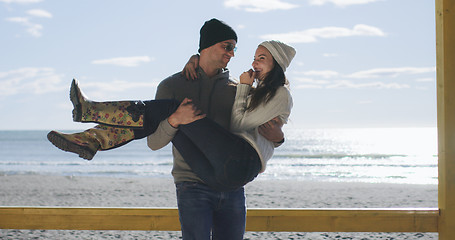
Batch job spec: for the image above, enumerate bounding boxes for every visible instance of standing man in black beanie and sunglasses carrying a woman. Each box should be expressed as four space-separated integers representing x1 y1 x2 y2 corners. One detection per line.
147 19 283 240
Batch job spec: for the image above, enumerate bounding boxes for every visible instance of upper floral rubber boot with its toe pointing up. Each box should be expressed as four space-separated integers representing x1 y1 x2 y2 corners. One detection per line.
70 79 145 128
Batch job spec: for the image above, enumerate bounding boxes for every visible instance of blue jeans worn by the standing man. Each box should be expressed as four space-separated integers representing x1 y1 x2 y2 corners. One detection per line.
176 182 246 240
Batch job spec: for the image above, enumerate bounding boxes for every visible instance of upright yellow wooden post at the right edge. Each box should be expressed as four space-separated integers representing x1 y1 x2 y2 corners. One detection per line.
435 0 455 240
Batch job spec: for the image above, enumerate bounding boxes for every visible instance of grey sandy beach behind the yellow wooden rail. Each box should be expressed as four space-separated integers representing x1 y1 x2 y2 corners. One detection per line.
0 175 438 240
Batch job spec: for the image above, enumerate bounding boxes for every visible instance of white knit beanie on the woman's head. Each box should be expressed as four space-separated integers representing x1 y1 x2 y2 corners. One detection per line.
259 40 295 72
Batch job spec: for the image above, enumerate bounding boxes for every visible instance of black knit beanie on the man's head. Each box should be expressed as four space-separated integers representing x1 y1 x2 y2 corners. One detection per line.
198 18 237 52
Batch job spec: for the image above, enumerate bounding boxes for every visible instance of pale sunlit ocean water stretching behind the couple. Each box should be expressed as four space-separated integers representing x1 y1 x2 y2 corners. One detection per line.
0 128 438 184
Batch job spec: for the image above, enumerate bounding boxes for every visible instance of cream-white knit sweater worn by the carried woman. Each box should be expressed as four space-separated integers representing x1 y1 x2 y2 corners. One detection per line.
231 84 292 172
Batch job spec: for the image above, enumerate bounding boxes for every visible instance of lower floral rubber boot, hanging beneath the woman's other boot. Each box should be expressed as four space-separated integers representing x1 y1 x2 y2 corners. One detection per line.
47 125 134 160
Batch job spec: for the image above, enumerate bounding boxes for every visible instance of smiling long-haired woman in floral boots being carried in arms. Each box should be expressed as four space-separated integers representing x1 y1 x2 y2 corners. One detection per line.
48 41 295 191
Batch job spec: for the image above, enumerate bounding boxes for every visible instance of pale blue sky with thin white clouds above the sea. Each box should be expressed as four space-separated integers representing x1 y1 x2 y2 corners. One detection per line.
0 0 436 130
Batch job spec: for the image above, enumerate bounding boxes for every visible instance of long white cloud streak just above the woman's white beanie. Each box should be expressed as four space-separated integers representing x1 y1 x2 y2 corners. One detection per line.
260 24 386 43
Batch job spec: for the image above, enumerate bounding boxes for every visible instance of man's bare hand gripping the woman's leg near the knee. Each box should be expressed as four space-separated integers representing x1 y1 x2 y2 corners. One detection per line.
167 98 205 128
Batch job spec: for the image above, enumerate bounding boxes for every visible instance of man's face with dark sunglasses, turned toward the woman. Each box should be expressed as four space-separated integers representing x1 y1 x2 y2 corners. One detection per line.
207 39 237 68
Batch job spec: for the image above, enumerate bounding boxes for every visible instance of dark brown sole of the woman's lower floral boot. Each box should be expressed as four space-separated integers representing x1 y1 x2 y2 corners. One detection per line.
47 131 95 161
